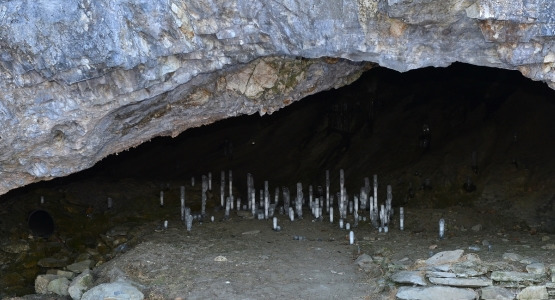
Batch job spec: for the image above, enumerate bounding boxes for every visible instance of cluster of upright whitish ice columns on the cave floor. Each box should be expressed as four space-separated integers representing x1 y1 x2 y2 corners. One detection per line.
156 169 416 243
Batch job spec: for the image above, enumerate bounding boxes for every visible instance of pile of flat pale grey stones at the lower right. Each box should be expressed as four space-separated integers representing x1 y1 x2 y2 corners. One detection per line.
376 250 555 300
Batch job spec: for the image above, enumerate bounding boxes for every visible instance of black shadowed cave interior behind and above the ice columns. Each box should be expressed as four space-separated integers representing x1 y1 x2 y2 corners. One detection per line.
0 63 555 294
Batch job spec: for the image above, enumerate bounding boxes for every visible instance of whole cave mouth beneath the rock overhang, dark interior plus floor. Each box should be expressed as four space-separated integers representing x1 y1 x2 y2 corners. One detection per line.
0 63 555 299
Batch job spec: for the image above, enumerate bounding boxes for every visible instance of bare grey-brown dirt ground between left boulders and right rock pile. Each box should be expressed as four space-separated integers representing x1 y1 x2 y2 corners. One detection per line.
90 203 555 299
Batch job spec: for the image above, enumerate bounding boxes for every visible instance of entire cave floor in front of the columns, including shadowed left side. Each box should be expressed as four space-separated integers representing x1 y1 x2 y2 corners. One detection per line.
0 189 555 299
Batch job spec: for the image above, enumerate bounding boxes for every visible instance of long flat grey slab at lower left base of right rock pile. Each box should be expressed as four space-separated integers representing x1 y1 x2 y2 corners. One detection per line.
396 286 478 300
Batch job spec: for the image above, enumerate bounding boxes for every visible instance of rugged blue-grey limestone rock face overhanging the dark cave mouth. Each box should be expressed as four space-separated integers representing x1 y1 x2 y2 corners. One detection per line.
0 0 555 194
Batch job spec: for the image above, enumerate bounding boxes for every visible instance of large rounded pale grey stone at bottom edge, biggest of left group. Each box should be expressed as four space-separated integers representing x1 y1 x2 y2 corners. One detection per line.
81 281 144 300
